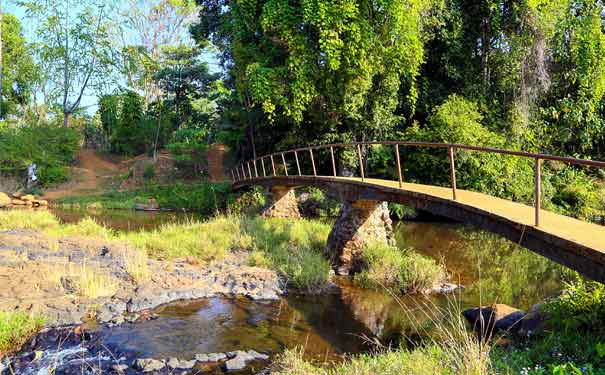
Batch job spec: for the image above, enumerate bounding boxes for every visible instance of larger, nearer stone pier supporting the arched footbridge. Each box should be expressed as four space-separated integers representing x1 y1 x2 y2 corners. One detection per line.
326 200 395 275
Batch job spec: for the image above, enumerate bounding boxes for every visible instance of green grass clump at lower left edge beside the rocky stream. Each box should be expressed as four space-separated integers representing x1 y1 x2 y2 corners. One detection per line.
0 311 44 358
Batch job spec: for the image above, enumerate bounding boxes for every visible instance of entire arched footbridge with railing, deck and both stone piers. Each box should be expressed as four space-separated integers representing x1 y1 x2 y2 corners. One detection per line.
230 141 605 282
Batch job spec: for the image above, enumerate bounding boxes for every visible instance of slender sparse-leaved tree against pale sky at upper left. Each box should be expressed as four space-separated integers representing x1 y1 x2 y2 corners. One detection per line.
18 0 115 126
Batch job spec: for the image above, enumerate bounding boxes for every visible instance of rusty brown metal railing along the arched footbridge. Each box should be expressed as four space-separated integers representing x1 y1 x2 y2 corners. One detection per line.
230 141 605 226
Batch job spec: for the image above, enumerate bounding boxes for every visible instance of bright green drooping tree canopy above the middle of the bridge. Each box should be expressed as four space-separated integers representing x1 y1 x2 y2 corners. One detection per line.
192 0 427 159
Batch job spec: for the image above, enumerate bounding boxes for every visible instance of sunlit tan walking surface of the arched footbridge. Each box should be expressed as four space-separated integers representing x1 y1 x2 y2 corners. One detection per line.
336 177 605 253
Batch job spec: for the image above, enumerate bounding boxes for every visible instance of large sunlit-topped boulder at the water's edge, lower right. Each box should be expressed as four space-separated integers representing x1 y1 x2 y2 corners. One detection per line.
462 303 526 336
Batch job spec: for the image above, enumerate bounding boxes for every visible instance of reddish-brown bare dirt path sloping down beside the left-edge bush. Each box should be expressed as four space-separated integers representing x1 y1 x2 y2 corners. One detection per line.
43 149 123 201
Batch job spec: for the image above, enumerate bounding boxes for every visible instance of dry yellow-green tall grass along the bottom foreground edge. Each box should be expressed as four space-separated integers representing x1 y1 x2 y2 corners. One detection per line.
270 301 495 375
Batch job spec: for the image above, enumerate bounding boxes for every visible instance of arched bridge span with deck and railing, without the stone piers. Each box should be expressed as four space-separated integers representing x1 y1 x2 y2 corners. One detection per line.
231 142 605 282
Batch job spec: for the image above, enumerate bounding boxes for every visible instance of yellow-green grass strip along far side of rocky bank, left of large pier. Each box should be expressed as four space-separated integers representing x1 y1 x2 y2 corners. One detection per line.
0 211 330 292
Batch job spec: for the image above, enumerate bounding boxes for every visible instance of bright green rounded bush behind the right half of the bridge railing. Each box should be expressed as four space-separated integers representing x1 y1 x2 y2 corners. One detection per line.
405 95 532 203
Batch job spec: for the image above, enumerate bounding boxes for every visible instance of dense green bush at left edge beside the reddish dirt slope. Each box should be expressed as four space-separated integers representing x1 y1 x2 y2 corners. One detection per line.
0 124 80 186
